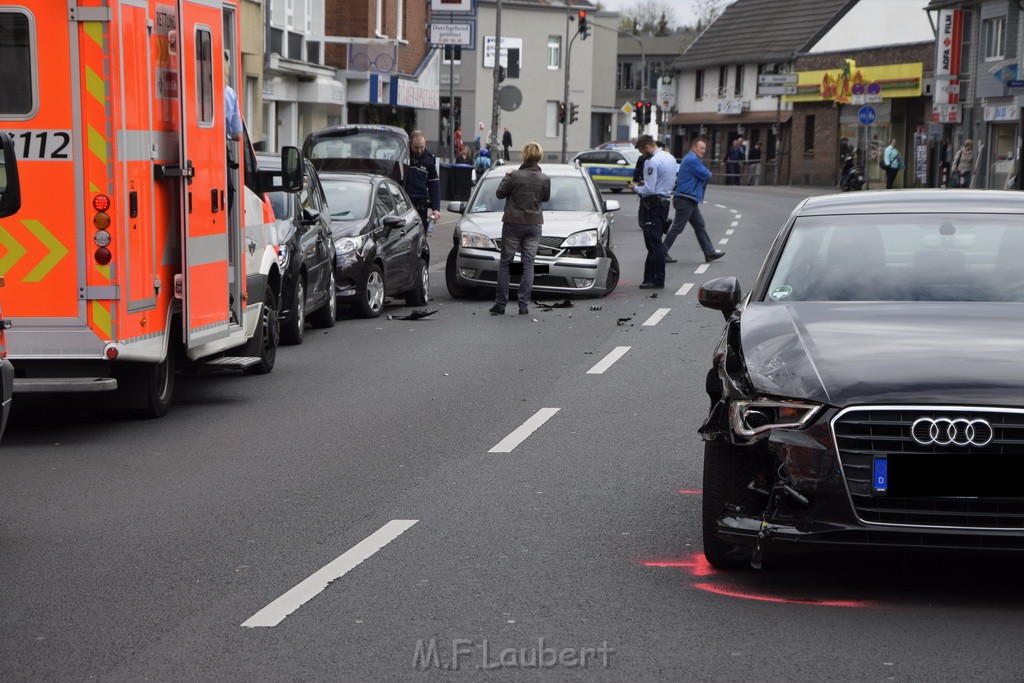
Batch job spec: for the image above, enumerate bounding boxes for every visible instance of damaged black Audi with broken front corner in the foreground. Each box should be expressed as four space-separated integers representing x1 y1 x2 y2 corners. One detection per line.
698 190 1024 567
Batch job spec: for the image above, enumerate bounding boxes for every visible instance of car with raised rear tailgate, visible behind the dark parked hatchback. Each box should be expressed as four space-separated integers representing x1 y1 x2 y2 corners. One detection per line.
302 124 409 183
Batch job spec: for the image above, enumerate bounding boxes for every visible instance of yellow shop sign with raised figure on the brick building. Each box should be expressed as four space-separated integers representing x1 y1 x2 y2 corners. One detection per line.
783 59 925 104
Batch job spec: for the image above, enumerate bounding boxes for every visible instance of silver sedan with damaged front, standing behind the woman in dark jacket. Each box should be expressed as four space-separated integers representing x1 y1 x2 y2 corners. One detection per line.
445 164 620 299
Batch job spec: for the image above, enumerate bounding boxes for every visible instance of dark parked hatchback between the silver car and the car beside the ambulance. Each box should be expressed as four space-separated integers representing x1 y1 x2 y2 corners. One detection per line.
321 172 430 317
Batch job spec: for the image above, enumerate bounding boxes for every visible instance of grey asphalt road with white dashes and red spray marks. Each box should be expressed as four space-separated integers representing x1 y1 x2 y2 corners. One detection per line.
0 186 1024 681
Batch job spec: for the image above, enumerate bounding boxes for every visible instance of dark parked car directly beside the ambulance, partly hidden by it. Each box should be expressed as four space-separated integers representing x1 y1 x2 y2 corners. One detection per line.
257 155 338 344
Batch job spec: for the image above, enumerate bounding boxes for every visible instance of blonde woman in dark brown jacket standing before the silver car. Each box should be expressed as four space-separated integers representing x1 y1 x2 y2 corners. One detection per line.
489 142 551 315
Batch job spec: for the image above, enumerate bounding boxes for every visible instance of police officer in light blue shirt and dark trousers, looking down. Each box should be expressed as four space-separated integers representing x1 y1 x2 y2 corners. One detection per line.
629 135 676 290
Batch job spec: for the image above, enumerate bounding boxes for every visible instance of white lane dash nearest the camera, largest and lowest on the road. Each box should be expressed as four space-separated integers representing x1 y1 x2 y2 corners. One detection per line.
242 519 420 629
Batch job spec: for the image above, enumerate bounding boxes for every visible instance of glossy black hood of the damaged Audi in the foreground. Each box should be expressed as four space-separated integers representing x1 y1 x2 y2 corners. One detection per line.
739 302 1024 408
